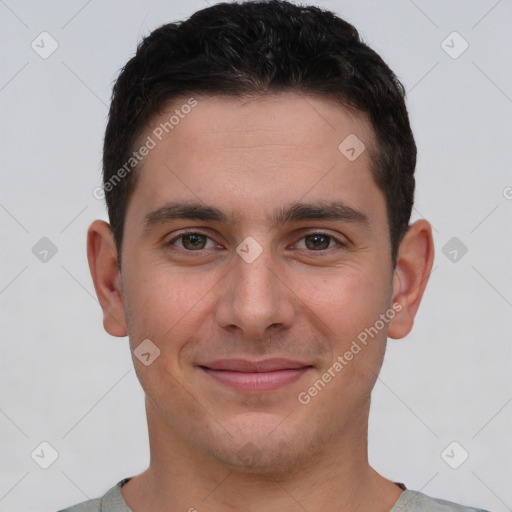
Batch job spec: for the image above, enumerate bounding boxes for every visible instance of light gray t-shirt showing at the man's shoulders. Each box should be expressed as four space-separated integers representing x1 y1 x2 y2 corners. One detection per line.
59 478 487 512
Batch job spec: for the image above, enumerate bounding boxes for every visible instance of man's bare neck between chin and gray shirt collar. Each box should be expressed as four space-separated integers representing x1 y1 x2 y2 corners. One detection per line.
122 402 402 512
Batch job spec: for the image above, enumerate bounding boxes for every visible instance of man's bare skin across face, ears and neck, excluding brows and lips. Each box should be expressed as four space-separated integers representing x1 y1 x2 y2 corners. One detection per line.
88 93 434 512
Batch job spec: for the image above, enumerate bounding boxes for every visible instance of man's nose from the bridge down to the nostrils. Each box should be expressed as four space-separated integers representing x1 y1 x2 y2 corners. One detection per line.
215 247 296 340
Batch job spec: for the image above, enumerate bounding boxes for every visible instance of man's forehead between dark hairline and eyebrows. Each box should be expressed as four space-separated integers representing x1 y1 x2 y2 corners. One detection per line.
128 93 385 229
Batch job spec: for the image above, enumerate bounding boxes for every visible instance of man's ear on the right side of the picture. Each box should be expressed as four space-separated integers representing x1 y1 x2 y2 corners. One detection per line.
388 219 434 339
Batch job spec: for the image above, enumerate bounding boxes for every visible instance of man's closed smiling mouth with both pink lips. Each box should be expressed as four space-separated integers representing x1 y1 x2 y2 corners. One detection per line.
199 359 313 392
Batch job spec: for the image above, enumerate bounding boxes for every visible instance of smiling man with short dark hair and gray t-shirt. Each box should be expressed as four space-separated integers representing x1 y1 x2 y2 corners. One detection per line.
61 1 492 512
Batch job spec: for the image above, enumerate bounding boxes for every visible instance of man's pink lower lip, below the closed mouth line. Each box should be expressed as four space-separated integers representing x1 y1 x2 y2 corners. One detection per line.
203 366 311 392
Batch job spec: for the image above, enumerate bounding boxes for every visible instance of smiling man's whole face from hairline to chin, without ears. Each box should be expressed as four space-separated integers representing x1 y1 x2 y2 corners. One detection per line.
106 93 406 471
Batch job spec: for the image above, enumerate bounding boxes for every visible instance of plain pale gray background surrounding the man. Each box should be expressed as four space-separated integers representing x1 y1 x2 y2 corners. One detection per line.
0 0 512 512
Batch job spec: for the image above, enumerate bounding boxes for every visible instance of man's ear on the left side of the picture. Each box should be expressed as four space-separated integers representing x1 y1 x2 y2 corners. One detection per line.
87 220 128 337
